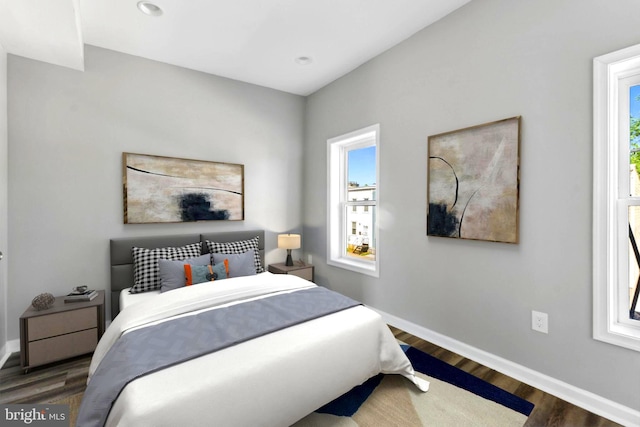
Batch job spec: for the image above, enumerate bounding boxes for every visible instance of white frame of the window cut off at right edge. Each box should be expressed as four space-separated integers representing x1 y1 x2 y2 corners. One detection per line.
593 45 640 351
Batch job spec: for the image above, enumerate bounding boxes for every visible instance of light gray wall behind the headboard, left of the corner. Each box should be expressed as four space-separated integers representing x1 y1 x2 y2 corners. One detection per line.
8 46 304 339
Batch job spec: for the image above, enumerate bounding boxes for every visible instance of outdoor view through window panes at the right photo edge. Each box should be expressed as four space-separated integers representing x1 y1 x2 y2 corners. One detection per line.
628 85 640 320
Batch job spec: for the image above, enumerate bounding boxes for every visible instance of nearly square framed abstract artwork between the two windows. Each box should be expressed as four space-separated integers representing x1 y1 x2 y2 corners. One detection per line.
427 116 520 243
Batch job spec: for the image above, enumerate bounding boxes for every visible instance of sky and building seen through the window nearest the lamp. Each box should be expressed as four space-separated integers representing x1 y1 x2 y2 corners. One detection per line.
346 145 376 260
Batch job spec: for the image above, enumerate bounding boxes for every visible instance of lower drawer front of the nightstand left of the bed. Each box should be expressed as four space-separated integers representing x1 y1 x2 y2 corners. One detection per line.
28 328 98 366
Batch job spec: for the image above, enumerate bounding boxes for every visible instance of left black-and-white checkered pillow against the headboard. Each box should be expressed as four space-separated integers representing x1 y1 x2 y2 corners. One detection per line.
134 242 201 294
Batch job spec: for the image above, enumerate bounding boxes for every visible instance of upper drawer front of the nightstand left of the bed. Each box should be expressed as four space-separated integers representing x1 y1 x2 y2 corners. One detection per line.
27 303 98 341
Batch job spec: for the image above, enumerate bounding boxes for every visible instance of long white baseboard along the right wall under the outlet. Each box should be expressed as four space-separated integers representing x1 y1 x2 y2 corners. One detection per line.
370 307 640 427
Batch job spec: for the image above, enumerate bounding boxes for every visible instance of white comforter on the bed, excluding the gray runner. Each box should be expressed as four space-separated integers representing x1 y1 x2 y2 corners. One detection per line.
89 273 428 427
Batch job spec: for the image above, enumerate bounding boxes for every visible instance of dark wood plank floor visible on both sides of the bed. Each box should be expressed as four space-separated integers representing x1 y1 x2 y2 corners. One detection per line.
0 328 619 427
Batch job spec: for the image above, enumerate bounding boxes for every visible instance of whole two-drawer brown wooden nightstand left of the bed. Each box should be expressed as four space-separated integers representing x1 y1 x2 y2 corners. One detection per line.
20 291 104 373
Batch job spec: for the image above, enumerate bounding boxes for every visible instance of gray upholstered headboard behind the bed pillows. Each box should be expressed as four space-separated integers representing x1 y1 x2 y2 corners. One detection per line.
110 230 265 319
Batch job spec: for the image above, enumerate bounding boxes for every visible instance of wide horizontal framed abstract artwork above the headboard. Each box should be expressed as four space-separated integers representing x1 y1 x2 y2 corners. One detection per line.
122 153 244 224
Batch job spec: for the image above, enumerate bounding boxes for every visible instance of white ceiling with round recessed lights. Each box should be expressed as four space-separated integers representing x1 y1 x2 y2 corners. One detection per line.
0 0 470 95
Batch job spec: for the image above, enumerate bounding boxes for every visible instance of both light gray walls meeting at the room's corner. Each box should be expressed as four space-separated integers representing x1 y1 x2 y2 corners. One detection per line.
0 0 640 416
